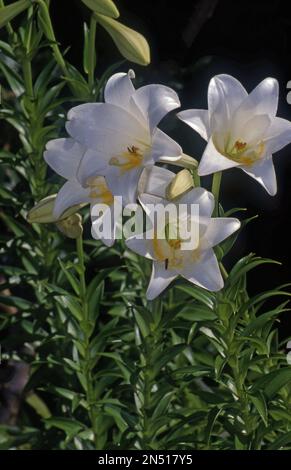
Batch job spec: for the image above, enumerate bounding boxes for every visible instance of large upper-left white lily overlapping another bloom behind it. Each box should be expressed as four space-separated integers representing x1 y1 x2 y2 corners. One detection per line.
66 71 182 205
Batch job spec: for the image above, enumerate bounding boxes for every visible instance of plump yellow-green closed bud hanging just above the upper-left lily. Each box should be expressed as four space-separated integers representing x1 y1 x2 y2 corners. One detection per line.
95 13 150 65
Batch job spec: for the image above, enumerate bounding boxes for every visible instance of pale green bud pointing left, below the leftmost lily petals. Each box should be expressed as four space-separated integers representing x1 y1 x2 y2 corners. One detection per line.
26 194 85 224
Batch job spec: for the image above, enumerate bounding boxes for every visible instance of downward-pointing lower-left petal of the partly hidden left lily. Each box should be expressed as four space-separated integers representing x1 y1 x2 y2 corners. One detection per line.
53 180 91 218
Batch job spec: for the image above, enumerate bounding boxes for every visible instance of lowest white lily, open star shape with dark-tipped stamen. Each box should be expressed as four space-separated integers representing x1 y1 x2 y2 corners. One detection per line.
126 168 240 300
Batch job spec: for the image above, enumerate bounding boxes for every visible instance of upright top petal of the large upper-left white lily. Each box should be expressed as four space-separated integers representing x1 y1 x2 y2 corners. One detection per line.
104 70 135 110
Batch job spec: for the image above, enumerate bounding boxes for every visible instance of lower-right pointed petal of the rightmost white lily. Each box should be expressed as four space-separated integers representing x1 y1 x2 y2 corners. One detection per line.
241 156 277 196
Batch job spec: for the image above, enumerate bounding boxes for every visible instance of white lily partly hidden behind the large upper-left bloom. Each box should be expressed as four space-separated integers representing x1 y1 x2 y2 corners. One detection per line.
44 139 117 246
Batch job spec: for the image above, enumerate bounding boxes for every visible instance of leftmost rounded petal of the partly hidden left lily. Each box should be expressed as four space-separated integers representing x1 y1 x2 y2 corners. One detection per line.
44 139 86 179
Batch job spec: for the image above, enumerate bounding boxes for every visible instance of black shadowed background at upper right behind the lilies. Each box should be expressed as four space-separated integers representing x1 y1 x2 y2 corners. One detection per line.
51 0 291 335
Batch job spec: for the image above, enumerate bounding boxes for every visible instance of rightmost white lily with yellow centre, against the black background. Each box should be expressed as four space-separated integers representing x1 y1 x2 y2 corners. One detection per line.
178 75 291 196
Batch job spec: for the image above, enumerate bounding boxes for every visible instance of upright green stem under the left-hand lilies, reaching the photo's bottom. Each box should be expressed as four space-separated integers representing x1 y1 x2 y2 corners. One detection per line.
76 236 101 450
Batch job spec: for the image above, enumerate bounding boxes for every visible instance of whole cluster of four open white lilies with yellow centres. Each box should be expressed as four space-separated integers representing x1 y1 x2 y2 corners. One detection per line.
44 71 291 299
